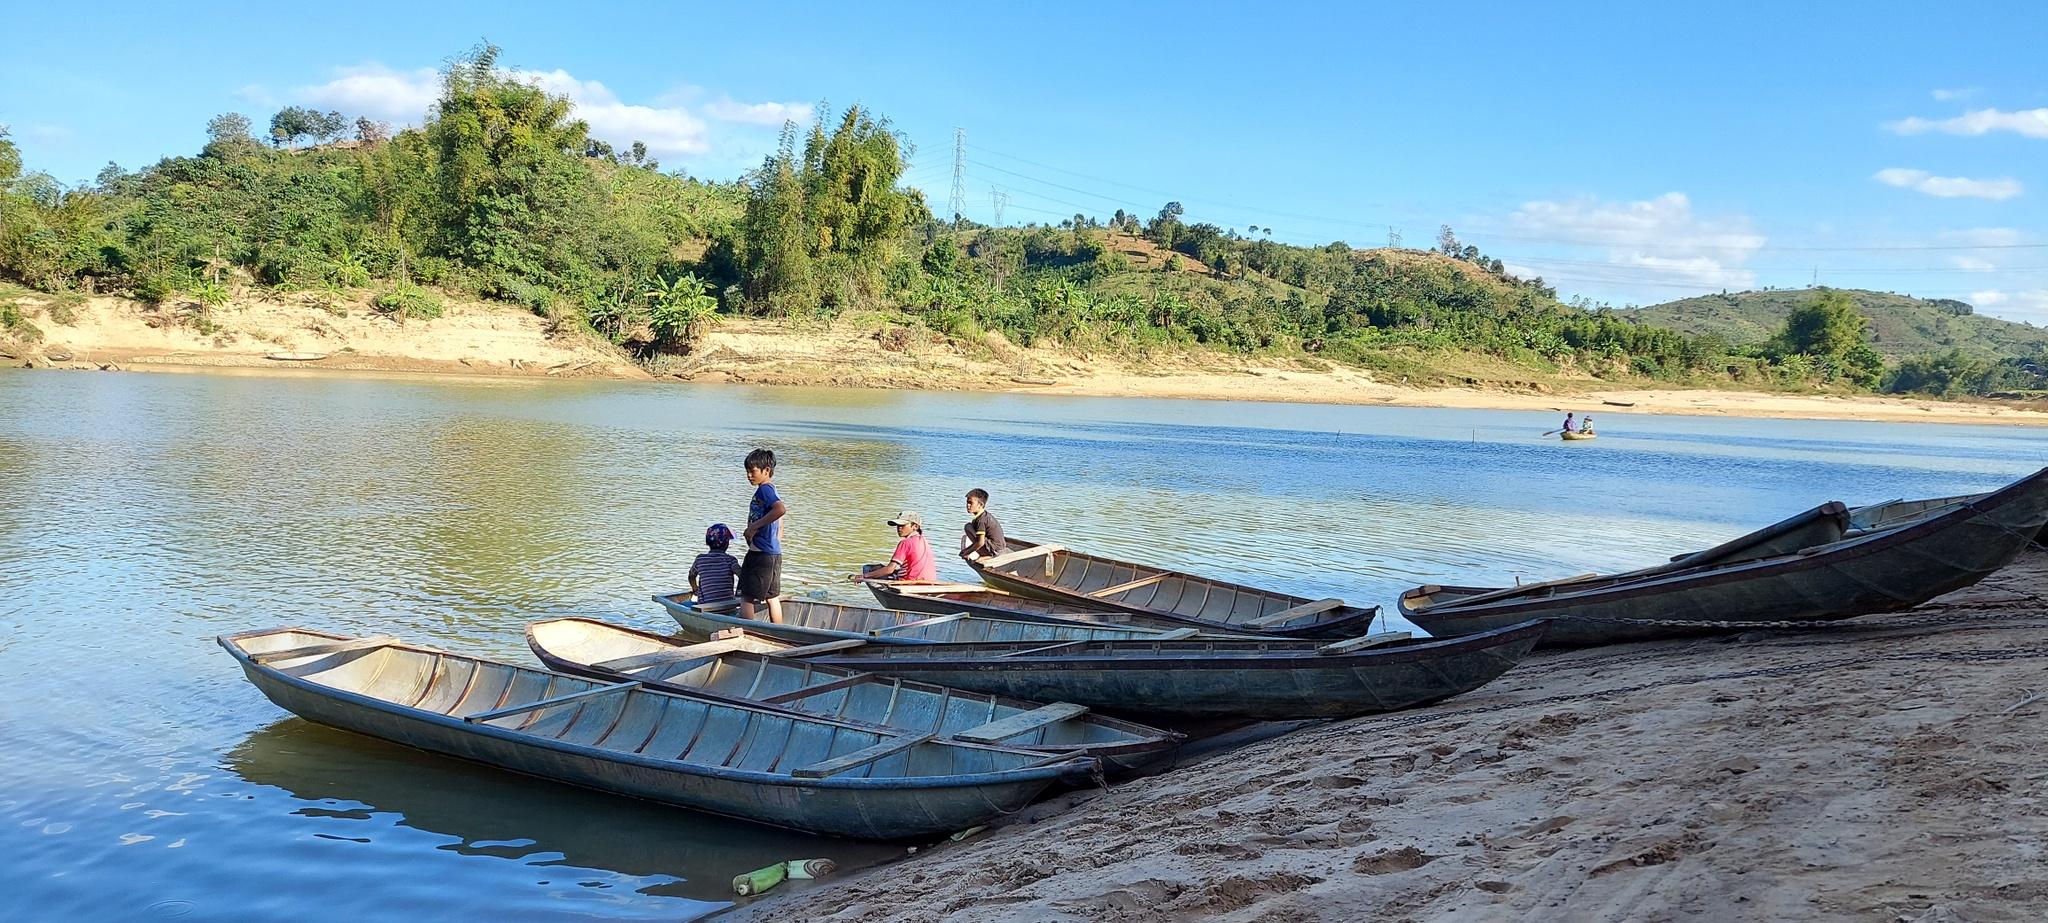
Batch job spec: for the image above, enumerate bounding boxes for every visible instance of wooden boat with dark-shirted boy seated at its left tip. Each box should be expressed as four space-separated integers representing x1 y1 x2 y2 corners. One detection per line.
967 538 1380 639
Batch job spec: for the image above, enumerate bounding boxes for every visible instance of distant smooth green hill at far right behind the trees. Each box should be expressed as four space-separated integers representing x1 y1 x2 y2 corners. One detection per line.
1618 289 2048 362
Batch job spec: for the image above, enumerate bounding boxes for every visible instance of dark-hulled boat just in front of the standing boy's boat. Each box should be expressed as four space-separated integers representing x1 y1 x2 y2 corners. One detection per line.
778 622 1546 720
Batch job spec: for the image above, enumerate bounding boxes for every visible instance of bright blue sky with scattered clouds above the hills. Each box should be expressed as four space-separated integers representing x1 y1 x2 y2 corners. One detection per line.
0 2 2048 323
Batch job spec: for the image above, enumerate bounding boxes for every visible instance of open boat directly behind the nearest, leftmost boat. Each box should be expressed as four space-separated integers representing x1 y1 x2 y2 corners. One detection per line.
526 618 1180 770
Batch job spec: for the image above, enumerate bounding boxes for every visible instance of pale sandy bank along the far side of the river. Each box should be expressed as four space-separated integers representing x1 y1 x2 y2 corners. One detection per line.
0 293 2048 426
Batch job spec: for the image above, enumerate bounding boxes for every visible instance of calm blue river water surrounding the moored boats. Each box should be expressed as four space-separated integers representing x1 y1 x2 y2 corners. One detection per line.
0 372 2048 919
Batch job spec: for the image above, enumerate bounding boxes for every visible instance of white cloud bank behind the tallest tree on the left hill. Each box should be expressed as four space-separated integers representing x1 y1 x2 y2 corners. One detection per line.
270 61 811 158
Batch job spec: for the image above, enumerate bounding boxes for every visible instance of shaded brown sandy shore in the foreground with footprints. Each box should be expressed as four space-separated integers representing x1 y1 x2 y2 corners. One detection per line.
721 553 2048 923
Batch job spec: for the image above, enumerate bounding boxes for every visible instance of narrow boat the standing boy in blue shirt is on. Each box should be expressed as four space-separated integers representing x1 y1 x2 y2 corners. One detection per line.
653 589 1196 645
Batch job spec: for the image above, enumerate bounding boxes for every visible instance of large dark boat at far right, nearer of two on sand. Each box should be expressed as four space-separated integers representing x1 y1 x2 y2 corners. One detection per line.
1401 469 2048 645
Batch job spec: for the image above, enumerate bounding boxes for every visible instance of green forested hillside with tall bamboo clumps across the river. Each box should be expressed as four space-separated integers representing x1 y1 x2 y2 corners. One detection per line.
0 47 2038 401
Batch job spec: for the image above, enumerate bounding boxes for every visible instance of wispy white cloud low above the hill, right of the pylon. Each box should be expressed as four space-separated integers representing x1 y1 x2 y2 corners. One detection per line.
1509 192 1765 301
